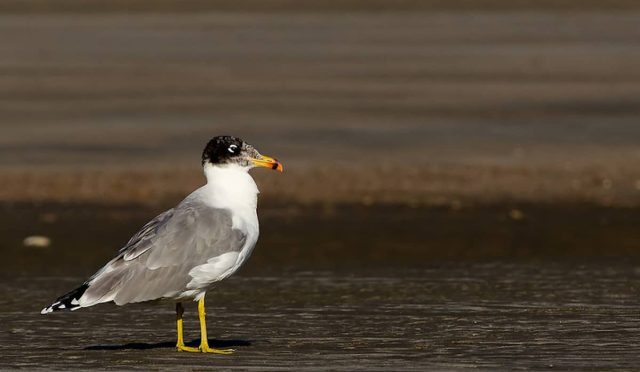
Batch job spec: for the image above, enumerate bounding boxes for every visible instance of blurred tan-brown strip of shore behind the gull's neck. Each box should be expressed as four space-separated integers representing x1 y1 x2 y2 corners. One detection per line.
0 159 640 208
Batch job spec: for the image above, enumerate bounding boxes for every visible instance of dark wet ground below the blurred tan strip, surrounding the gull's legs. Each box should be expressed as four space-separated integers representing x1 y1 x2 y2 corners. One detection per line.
0 204 640 371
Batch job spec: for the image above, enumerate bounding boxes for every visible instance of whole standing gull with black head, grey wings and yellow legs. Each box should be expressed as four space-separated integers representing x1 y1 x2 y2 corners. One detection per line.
41 136 283 354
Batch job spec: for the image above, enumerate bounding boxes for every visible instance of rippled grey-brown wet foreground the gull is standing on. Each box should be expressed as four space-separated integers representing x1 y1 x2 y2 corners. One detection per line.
0 262 640 370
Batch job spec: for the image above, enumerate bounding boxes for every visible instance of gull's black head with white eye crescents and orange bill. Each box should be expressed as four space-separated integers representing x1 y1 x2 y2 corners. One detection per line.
202 136 282 171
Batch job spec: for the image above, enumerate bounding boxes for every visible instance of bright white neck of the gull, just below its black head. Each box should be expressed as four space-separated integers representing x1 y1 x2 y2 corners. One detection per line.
203 164 260 211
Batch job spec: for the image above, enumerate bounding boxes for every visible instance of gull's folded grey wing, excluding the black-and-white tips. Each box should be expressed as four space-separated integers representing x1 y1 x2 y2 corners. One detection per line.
80 200 246 306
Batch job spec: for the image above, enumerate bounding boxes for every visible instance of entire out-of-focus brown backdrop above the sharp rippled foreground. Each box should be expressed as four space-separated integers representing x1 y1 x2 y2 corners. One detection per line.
0 0 640 274
